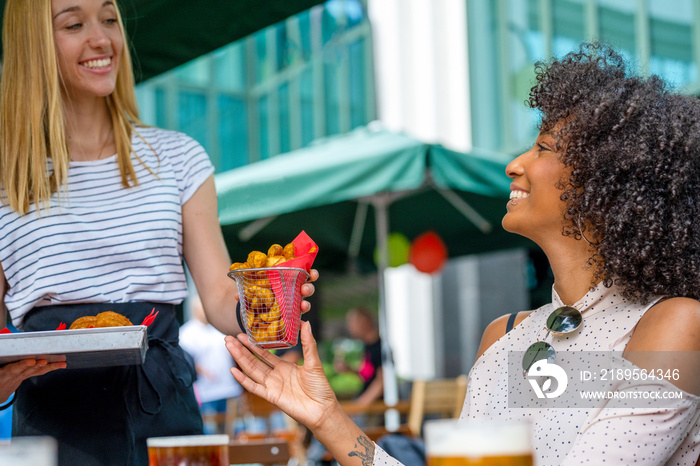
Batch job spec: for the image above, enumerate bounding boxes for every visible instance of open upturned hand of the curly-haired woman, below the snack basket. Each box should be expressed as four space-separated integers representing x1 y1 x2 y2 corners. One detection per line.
226 322 338 430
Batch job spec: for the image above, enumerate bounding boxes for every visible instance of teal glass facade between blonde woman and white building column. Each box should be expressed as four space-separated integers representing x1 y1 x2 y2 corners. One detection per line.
137 0 376 171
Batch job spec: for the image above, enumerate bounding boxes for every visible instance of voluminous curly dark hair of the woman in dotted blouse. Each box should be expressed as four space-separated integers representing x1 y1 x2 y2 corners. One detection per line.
527 43 700 302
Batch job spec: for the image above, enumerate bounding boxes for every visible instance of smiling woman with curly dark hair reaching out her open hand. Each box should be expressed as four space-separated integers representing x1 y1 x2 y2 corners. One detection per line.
227 44 700 466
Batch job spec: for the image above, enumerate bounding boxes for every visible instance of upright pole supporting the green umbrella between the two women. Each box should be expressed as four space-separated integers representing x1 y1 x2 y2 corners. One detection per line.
372 193 400 432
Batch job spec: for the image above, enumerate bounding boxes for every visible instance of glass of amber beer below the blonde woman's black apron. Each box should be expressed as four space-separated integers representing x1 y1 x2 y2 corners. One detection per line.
146 435 230 466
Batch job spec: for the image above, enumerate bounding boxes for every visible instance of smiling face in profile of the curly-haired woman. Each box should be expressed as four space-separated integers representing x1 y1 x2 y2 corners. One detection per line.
502 124 570 244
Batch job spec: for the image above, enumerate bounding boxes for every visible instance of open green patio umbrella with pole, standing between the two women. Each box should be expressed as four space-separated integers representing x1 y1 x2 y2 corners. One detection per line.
216 128 528 426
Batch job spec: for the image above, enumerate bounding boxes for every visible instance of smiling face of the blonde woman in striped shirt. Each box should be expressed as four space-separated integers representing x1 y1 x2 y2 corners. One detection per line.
51 0 124 98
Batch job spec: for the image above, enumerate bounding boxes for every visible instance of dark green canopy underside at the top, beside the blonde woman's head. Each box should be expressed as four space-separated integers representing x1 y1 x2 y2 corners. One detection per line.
0 0 323 81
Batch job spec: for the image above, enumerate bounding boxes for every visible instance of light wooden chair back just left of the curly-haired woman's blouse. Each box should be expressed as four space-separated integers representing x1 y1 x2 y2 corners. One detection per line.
407 375 467 436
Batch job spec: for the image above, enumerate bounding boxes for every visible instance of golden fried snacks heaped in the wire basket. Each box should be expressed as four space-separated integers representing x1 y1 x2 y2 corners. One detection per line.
229 243 295 342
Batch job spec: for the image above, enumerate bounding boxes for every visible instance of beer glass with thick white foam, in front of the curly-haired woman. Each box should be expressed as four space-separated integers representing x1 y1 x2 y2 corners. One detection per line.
424 419 533 466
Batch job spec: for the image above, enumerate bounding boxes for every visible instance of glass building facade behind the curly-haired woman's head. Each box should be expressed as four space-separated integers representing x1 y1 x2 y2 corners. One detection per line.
467 0 700 153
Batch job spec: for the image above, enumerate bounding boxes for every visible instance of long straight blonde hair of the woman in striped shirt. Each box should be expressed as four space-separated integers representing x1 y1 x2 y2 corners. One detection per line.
0 0 143 214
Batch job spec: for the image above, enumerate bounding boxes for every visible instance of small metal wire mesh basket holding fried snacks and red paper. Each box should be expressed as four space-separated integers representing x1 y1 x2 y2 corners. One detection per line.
228 267 309 349
